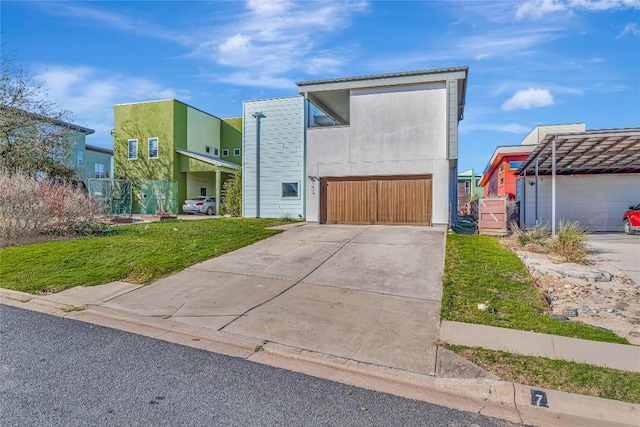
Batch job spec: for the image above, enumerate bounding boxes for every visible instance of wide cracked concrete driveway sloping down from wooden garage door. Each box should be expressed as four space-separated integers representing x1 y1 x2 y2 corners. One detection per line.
102 224 446 374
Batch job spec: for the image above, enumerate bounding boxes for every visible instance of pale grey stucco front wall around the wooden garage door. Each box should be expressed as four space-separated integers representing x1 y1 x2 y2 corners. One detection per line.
306 83 450 224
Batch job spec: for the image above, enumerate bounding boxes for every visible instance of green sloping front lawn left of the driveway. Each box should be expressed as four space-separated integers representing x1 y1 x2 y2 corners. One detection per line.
0 218 285 293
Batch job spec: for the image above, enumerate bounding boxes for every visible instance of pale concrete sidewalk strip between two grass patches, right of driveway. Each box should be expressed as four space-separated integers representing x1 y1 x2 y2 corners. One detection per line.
439 320 640 372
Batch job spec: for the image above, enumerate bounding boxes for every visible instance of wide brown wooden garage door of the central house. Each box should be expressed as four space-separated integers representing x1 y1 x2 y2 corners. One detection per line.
321 175 431 225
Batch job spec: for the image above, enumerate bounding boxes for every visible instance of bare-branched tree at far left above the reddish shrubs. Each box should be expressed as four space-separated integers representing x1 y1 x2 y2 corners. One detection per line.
0 56 75 181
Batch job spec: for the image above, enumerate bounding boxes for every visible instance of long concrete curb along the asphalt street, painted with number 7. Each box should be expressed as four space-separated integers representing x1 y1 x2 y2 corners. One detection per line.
0 289 640 427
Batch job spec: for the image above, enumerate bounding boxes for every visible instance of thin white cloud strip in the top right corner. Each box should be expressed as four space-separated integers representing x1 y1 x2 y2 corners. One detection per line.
516 0 640 19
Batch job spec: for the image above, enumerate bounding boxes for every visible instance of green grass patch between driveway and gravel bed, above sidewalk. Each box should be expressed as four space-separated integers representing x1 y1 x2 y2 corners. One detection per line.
440 233 628 344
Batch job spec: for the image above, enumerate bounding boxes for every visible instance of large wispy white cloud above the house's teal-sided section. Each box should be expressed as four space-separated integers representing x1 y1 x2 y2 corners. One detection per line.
192 0 368 88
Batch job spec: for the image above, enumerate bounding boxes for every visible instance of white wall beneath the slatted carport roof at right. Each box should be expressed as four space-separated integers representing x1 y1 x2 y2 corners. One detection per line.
517 174 640 231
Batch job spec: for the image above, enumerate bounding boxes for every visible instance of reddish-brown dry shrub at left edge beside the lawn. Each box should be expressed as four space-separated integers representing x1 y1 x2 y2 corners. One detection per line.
0 169 99 246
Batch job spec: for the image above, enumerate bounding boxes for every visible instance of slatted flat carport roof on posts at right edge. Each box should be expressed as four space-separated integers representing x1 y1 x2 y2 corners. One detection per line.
516 128 640 175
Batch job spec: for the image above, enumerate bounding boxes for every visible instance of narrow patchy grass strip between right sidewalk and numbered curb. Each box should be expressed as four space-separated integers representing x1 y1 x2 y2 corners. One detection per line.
445 345 640 404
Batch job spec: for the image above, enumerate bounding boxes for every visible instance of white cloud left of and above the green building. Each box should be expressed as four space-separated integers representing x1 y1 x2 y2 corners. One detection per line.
34 65 189 145
